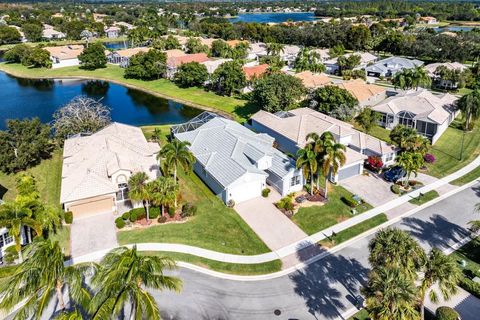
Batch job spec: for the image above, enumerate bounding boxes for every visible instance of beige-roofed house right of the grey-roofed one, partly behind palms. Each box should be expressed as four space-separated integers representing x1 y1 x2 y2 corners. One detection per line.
247 108 397 182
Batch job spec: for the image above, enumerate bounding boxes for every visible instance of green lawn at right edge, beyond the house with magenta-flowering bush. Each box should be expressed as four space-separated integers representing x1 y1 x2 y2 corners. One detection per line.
427 120 480 178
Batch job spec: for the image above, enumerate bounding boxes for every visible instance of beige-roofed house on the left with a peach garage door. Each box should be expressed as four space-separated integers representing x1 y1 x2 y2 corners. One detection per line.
60 122 160 218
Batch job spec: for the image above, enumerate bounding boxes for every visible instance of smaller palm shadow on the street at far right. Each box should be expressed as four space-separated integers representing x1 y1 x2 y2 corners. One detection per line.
402 214 471 249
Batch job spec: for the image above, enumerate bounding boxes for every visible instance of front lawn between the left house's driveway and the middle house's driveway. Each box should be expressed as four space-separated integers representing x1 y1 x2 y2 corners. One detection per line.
118 168 270 255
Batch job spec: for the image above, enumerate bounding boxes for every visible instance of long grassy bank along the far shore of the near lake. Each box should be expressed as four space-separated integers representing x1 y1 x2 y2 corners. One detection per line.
0 63 257 121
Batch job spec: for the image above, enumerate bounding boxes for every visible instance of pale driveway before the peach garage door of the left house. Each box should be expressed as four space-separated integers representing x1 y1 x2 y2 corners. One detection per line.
70 213 118 257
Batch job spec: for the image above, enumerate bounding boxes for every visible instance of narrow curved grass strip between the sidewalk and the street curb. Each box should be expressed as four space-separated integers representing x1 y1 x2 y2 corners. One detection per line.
145 251 282 275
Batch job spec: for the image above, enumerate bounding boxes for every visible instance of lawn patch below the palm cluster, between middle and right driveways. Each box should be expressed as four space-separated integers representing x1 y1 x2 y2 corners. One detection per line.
292 184 372 235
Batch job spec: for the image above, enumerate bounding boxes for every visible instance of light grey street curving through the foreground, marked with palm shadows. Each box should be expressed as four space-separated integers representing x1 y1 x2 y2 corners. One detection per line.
155 185 480 320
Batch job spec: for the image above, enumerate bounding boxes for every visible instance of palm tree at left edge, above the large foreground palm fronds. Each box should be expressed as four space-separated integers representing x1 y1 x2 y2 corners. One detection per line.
0 200 39 262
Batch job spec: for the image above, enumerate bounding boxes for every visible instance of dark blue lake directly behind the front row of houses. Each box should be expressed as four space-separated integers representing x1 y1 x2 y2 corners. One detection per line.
0 72 202 129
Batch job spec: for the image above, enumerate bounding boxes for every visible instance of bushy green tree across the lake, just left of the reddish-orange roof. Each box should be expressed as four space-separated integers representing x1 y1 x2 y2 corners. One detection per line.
124 49 167 80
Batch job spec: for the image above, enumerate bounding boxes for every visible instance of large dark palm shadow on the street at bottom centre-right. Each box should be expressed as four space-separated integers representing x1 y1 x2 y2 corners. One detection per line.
290 241 369 319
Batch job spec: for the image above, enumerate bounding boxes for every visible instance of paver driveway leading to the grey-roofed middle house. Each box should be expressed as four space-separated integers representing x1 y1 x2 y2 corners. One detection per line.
235 189 307 250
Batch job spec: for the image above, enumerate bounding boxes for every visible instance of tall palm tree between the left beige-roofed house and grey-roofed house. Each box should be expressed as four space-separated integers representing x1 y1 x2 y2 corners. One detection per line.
157 139 195 183
